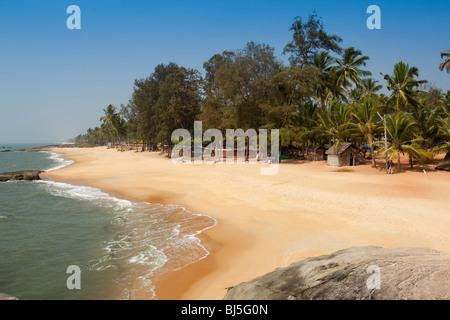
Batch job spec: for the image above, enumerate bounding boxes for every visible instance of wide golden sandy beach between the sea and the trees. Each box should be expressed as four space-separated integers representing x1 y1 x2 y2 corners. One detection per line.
42 147 450 299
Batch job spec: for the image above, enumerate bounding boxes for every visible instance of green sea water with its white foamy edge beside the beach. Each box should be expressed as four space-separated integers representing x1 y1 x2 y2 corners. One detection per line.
0 145 216 299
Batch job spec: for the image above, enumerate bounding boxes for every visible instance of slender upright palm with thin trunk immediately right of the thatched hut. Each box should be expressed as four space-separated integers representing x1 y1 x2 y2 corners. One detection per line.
352 98 381 168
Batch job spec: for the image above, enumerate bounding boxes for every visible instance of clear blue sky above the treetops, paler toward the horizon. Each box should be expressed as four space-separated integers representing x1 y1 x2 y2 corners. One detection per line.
0 0 450 143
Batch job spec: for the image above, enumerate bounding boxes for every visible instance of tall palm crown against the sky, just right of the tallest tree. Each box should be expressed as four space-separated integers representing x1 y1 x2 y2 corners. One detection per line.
332 47 372 101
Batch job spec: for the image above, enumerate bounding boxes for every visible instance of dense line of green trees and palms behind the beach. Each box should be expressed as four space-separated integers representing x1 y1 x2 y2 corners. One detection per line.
75 13 450 171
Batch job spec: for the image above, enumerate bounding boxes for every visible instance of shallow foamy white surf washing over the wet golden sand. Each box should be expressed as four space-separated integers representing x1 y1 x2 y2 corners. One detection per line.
35 180 218 298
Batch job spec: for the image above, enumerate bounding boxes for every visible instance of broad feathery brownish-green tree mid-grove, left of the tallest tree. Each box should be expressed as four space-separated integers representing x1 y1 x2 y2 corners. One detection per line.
200 42 281 129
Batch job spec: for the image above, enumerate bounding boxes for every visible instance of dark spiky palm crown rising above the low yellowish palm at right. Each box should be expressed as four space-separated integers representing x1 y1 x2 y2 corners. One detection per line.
382 61 427 112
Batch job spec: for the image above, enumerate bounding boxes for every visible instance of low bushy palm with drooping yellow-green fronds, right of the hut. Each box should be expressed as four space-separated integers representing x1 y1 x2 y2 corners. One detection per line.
375 112 432 171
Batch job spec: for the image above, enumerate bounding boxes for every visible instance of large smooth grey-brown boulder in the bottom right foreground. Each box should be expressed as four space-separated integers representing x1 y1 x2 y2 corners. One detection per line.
225 247 450 300
